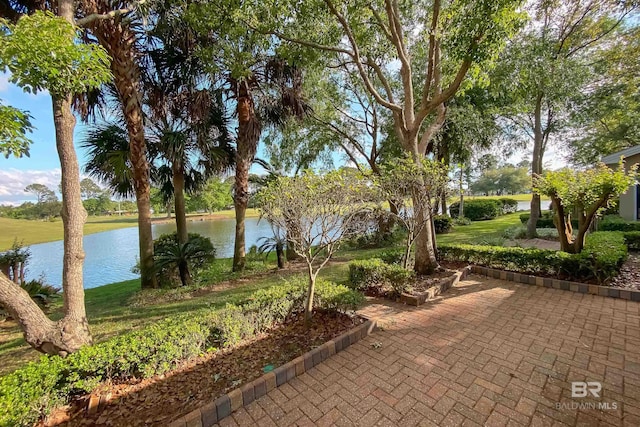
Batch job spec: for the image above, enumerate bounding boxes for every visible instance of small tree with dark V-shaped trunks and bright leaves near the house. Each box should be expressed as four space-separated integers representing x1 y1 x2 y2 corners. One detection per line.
533 161 638 253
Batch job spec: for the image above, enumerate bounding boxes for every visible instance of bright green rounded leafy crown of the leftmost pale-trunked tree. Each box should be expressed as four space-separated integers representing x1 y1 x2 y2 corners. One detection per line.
0 12 111 96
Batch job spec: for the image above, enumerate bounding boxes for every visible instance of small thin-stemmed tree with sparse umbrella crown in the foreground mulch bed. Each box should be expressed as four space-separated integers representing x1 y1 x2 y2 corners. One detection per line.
258 170 374 324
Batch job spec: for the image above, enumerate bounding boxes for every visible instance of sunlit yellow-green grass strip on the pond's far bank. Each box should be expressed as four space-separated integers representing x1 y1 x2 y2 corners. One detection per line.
0 209 259 251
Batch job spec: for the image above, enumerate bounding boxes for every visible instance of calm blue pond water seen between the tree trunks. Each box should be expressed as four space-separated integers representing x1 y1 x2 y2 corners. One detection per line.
27 218 272 289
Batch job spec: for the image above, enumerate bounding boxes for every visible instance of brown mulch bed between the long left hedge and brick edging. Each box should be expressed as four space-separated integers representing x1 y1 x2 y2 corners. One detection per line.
41 311 363 426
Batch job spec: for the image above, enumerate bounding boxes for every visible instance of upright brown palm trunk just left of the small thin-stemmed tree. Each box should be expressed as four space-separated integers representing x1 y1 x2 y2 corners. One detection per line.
233 80 262 271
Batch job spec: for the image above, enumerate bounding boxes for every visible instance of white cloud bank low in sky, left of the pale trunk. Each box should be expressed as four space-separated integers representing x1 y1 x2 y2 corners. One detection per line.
0 168 60 204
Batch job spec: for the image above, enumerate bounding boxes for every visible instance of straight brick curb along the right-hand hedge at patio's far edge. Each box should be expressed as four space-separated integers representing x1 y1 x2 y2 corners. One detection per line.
471 265 640 301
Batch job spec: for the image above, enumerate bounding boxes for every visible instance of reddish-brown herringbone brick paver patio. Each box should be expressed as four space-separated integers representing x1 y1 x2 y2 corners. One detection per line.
215 276 640 426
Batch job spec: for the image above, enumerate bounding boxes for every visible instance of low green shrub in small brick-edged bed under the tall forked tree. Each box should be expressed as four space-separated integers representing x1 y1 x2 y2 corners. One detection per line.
348 258 415 295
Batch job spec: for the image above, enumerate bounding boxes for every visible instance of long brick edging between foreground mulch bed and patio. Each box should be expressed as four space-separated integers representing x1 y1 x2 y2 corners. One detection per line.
169 319 377 427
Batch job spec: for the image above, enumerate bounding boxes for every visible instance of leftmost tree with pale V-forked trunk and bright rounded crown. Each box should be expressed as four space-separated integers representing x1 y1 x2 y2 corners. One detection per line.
0 11 110 356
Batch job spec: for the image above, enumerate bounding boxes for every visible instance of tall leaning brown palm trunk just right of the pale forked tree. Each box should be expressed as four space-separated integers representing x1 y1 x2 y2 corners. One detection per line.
87 18 158 289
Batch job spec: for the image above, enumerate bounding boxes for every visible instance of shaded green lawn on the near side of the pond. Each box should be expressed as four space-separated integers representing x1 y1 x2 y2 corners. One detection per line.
0 213 520 375
